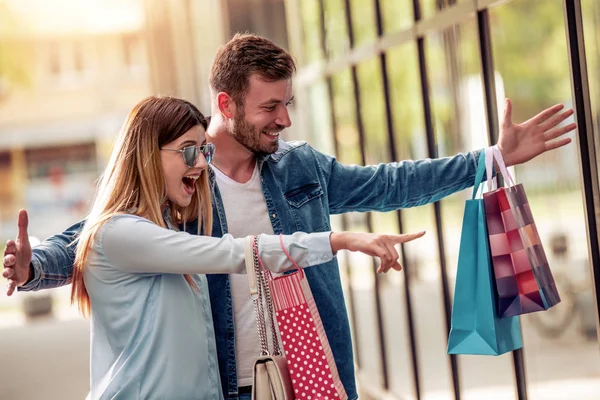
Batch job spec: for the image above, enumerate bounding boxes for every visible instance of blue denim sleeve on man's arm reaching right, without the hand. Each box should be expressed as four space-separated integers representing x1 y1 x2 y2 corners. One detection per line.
311 148 482 214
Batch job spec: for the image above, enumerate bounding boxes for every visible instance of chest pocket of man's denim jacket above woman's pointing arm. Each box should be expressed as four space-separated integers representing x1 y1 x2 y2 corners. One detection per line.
284 183 328 232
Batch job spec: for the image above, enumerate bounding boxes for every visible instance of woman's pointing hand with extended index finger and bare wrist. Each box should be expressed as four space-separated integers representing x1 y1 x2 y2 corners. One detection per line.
330 231 425 273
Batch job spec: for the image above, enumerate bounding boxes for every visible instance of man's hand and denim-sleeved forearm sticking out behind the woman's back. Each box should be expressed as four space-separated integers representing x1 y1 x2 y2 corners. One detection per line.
2 210 83 296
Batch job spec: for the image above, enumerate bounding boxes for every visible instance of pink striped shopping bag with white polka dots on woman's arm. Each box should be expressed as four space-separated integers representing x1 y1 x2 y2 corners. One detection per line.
256 237 348 400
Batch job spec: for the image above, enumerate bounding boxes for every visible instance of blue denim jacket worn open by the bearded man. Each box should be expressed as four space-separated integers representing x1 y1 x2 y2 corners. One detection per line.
21 141 486 399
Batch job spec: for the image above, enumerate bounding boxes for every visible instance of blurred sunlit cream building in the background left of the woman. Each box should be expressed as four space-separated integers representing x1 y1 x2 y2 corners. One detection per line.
0 0 151 238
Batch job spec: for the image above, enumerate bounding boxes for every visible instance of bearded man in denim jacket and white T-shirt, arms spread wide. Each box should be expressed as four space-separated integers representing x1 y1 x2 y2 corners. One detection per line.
3 35 575 399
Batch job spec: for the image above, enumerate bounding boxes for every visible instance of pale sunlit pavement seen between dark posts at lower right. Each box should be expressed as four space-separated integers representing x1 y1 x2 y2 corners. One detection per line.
354 282 600 400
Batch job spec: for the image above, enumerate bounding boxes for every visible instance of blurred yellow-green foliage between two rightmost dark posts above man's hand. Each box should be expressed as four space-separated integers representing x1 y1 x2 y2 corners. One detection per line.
490 0 571 122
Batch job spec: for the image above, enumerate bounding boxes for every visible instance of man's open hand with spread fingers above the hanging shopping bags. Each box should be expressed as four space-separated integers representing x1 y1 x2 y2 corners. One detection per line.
498 99 577 166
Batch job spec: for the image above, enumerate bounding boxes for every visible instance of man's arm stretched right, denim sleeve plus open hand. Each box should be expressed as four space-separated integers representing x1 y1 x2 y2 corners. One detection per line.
322 99 576 214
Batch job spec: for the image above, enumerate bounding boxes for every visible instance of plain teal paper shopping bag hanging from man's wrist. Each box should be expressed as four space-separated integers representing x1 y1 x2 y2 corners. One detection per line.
448 151 523 356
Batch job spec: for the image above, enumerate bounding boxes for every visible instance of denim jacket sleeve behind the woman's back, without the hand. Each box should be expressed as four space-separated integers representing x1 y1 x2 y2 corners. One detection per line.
19 221 85 291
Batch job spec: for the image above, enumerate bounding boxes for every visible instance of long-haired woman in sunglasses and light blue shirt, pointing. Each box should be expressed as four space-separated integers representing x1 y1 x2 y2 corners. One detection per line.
72 97 420 399
